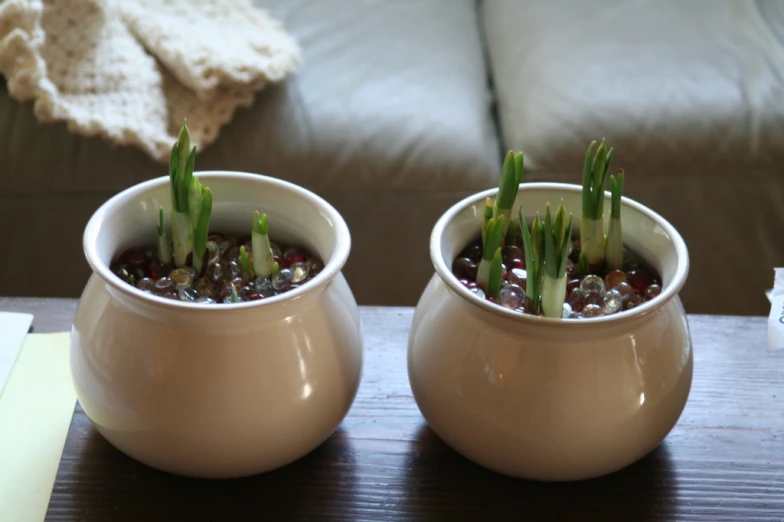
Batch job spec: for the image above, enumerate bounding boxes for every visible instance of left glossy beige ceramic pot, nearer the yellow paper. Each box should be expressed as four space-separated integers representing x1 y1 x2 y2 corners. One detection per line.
71 172 362 477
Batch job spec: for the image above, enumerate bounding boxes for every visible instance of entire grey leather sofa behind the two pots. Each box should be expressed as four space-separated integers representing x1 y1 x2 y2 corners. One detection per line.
0 0 784 314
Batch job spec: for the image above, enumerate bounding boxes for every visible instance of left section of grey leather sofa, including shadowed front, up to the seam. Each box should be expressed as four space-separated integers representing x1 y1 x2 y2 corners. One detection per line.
0 0 500 304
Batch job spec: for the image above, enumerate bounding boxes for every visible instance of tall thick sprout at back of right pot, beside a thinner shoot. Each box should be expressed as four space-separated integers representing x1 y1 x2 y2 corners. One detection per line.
580 139 613 268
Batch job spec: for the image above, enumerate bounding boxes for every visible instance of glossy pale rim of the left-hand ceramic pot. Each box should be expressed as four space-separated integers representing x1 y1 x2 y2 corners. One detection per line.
82 170 351 313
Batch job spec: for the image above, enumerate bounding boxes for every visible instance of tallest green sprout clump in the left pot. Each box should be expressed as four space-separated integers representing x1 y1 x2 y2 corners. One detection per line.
168 119 212 273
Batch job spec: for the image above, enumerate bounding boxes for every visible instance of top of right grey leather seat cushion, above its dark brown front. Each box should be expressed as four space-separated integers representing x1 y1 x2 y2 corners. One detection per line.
483 0 784 176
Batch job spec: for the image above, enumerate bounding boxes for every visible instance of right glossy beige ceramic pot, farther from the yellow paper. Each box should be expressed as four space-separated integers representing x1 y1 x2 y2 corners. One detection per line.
408 183 693 481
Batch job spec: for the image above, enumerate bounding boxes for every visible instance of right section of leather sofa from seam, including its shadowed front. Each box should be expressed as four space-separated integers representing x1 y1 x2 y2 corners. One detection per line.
482 0 784 314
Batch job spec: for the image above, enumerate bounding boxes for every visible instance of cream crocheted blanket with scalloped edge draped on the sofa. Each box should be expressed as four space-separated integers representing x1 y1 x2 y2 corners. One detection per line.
0 0 301 162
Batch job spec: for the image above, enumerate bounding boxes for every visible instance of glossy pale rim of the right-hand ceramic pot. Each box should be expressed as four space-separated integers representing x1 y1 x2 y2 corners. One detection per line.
430 182 689 322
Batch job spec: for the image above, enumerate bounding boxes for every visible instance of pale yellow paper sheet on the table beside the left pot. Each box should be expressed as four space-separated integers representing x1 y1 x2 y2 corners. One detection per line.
0 332 76 522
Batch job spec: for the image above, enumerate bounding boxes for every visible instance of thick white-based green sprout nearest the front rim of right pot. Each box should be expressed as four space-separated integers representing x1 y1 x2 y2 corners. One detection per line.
542 200 572 318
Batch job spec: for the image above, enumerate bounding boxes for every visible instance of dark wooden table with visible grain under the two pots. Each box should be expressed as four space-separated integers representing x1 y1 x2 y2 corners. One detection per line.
0 299 784 522
